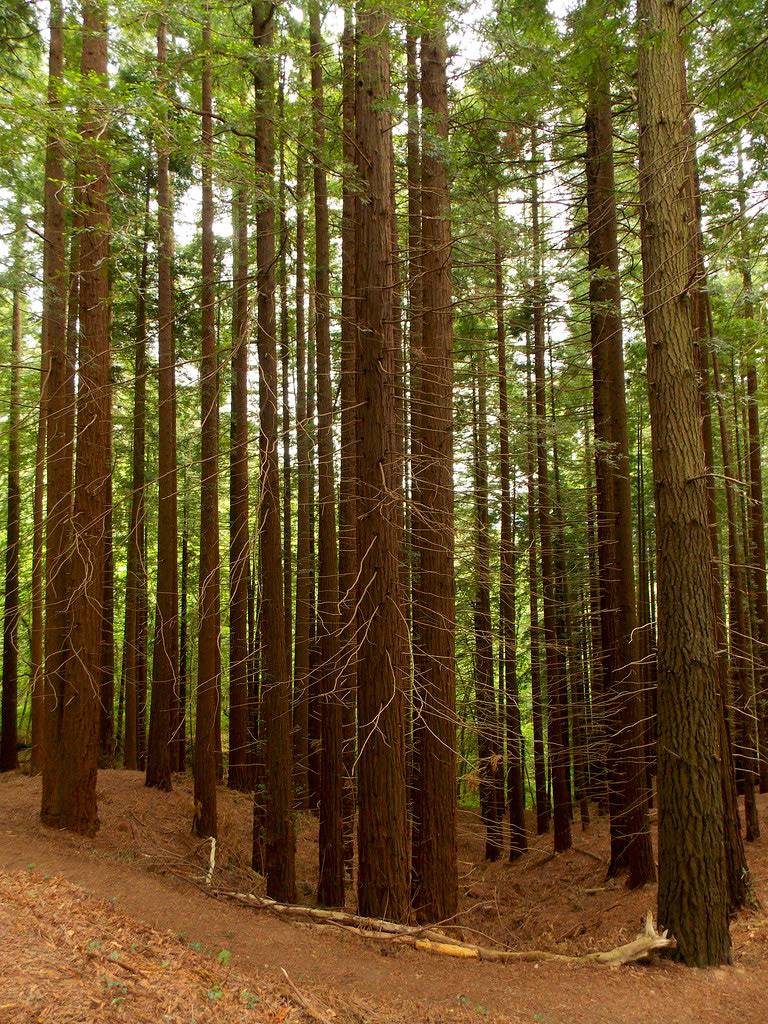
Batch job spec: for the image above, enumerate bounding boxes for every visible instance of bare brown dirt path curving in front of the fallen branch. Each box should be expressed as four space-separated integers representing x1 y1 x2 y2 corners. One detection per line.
0 773 768 1024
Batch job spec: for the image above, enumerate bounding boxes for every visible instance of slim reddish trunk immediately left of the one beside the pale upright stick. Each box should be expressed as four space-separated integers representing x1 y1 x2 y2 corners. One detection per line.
146 17 180 790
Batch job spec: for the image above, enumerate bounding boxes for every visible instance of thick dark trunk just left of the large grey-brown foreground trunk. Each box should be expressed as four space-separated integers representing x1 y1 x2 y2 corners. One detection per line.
587 74 655 888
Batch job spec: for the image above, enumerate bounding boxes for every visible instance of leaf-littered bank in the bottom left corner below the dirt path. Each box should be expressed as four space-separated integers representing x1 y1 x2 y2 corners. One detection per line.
0 870 303 1024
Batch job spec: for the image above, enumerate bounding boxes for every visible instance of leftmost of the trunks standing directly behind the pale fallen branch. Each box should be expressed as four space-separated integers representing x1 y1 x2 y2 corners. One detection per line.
252 0 296 902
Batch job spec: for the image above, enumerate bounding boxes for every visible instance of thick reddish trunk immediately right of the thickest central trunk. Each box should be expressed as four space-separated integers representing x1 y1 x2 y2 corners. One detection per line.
411 24 459 922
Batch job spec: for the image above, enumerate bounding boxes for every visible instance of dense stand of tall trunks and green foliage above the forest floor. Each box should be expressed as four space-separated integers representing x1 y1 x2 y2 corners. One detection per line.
0 0 768 964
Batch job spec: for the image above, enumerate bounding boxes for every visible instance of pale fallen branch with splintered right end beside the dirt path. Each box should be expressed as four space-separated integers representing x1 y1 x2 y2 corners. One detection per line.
214 890 676 967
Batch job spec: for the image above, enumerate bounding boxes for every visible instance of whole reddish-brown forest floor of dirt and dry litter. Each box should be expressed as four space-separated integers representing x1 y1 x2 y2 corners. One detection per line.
0 771 768 1024
